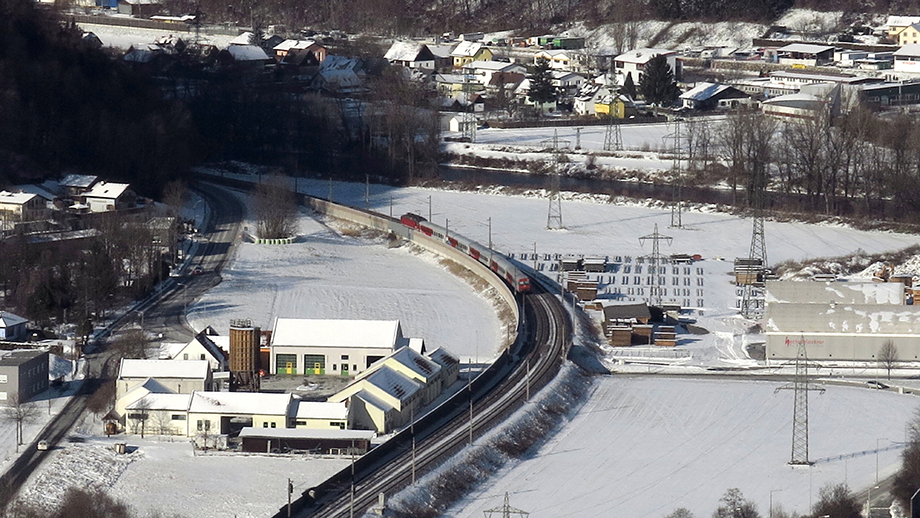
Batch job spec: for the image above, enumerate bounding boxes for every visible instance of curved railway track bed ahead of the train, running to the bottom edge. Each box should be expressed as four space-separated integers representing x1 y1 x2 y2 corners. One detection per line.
288 282 571 518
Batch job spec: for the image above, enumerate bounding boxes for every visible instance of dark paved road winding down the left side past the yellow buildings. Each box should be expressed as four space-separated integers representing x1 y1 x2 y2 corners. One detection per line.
0 184 243 509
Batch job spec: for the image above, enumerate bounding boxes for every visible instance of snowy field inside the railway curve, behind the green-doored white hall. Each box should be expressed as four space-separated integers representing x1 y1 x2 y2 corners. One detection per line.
188 189 501 362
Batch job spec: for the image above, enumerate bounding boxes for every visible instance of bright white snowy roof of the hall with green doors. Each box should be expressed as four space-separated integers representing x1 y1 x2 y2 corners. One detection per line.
272 318 402 349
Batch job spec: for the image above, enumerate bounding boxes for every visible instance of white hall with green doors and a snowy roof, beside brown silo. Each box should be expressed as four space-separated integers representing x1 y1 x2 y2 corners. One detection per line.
270 318 408 376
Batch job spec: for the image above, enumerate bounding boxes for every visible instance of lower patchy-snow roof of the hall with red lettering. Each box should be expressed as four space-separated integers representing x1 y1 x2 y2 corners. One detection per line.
765 304 920 335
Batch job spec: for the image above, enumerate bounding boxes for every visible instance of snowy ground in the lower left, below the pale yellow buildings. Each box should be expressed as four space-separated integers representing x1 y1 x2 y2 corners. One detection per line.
21 437 350 518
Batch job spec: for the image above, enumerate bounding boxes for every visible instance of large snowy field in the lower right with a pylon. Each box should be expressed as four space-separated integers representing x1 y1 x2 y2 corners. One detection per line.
445 376 920 518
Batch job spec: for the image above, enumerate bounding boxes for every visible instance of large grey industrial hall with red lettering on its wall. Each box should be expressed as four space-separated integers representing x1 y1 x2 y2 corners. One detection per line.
764 281 920 362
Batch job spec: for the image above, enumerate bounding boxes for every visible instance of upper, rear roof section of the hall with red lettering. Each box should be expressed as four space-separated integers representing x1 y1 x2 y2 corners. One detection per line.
766 281 904 304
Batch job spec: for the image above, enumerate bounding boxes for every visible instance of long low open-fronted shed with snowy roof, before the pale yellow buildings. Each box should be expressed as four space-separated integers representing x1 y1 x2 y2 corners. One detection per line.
240 426 377 455
